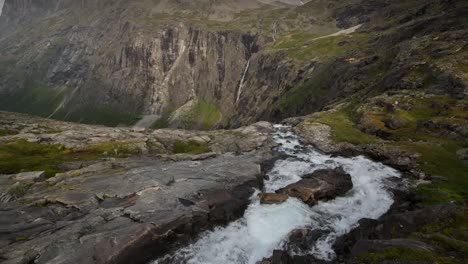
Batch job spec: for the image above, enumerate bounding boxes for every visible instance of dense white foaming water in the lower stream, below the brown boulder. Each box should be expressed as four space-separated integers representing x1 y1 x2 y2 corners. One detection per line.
155 199 311 264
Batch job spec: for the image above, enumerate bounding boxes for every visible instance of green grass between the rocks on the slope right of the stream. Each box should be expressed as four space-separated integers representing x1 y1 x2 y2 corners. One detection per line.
312 94 468 204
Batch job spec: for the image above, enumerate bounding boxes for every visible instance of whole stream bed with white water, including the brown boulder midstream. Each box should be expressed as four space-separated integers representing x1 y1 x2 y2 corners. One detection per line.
154 126 400 264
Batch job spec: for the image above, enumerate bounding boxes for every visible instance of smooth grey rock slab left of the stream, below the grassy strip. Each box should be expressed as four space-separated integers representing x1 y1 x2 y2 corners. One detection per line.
0 154 262 263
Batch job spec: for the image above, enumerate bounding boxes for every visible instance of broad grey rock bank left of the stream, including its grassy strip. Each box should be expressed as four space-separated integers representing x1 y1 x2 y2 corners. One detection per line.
0 112 272 263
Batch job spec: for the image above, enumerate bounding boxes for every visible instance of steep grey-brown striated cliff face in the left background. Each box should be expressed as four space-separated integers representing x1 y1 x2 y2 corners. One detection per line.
0 0 310 129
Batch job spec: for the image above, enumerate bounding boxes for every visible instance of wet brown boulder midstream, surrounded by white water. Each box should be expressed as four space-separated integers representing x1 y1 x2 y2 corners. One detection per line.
278 168 353 205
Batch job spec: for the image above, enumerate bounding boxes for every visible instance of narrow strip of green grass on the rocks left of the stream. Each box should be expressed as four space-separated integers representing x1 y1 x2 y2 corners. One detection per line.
0 140 141 177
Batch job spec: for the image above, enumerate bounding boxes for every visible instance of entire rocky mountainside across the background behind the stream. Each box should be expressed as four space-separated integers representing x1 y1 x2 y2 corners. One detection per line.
0 0 467 129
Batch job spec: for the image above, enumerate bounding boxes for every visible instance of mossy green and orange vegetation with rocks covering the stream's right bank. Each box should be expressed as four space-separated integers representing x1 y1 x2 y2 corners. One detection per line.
311 92 468 263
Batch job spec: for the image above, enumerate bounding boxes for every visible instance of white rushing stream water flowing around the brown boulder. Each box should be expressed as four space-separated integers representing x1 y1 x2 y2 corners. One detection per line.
153 125 400 264
